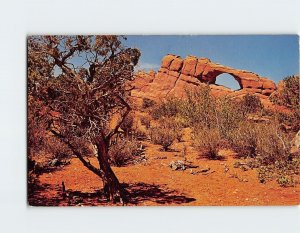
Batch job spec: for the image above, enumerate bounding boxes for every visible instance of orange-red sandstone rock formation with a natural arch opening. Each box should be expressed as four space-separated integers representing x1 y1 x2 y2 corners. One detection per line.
131 54 276 104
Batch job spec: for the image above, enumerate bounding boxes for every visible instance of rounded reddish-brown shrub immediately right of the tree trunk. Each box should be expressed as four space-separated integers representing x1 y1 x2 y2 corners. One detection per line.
109 139 142 167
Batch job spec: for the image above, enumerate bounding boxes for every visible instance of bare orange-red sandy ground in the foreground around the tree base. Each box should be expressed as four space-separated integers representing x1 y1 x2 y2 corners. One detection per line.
29 137 300 206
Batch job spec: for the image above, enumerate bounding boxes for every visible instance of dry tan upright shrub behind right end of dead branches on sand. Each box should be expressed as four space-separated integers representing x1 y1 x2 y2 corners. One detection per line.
193 127 223 159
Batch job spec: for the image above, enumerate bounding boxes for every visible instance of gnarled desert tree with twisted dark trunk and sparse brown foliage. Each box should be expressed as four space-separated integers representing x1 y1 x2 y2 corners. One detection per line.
28 35 140 201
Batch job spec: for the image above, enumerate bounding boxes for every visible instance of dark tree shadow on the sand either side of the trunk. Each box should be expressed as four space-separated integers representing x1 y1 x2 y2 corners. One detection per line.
28 183 196 206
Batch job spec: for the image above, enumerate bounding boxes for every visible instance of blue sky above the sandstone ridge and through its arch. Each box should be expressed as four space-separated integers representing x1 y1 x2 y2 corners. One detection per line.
124 35 299 89
